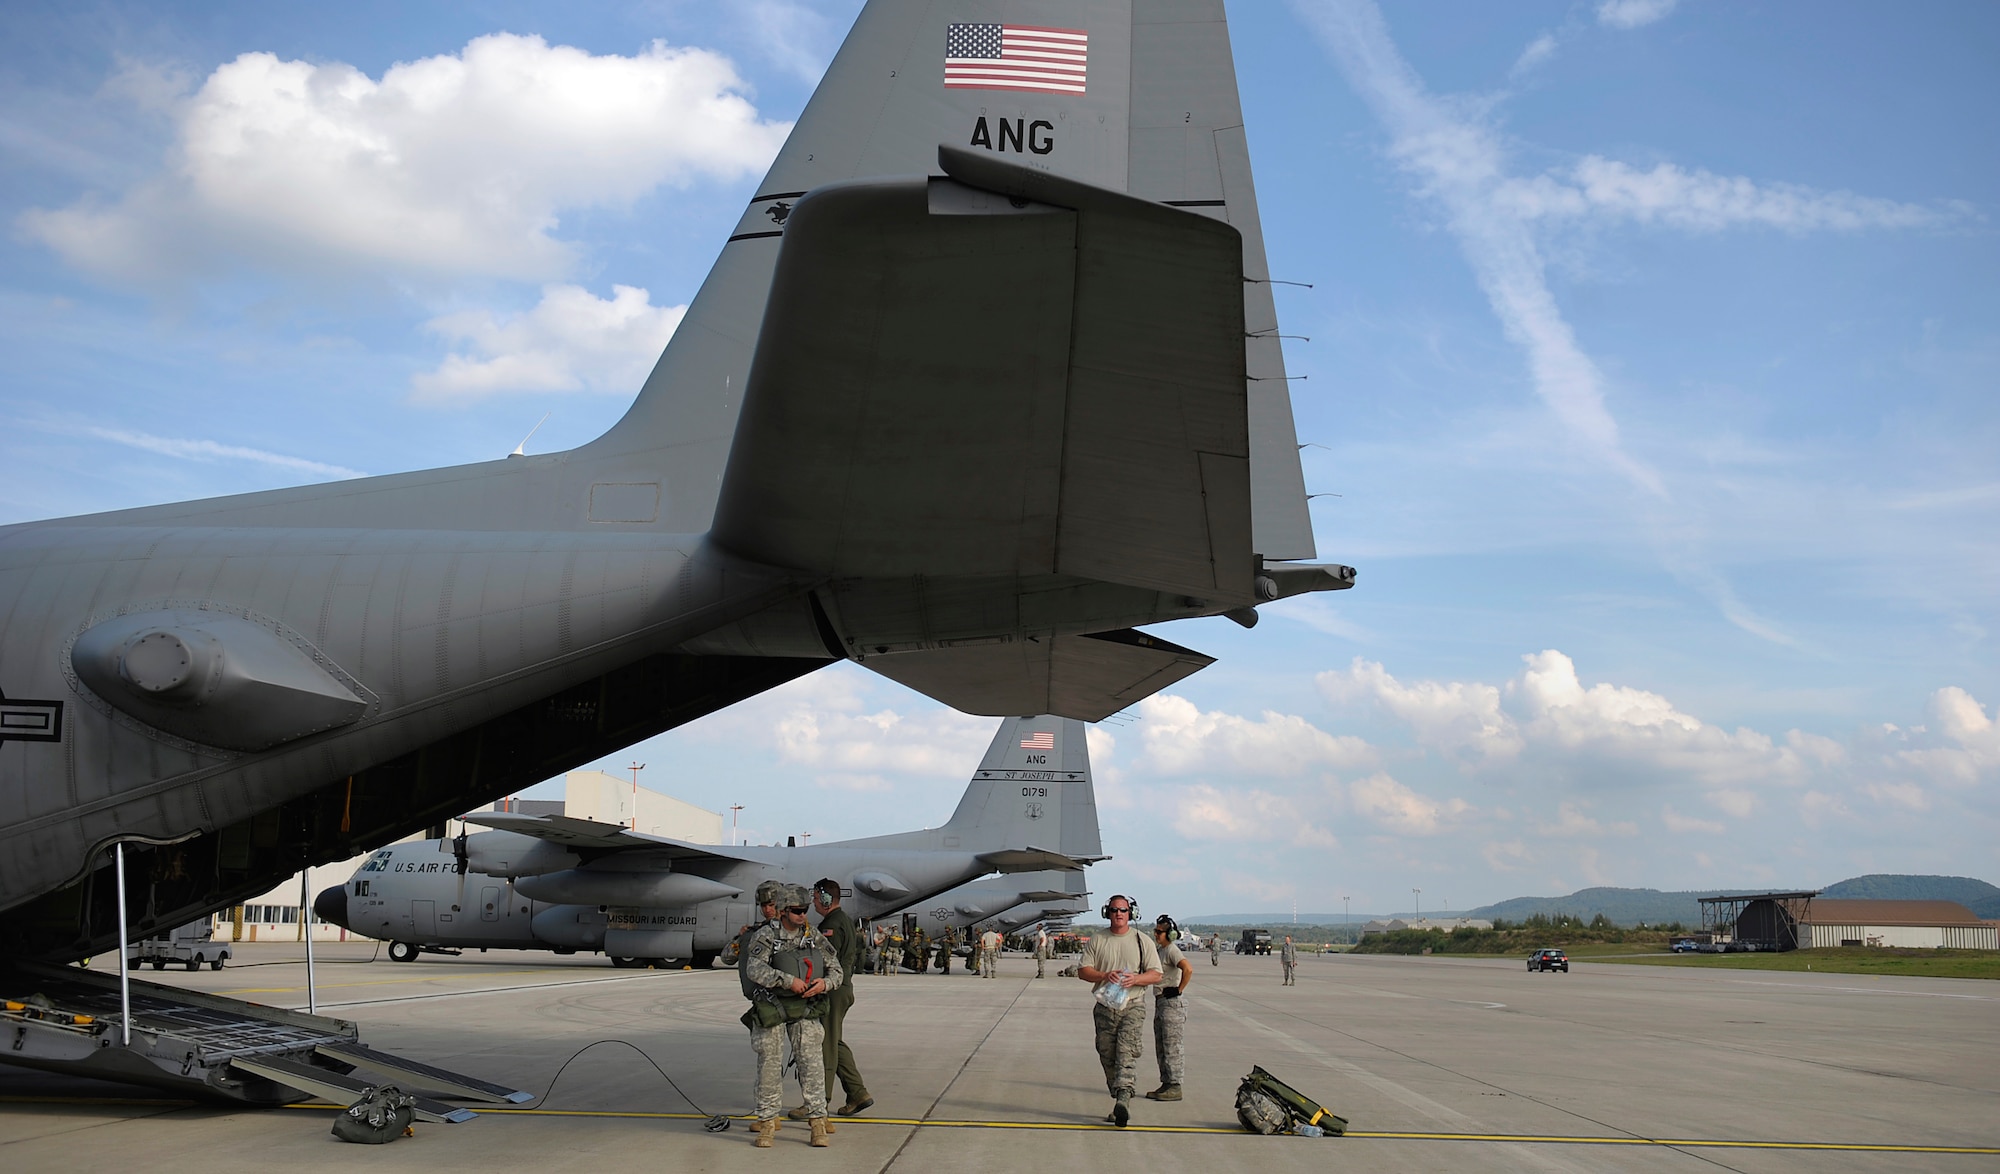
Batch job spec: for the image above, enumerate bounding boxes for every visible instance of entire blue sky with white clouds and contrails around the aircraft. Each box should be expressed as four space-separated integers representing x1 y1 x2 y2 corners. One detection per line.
0 0 2000 914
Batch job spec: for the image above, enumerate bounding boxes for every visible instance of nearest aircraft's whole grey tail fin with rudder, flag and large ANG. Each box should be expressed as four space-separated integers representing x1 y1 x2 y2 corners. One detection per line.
580 0 1314 558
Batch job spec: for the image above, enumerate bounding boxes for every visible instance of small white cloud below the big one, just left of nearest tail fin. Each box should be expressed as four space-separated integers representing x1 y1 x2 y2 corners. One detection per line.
410 286 688 400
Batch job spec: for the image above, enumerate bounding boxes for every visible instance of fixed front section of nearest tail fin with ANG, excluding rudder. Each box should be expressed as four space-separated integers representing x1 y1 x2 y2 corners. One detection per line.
586 0 1144 532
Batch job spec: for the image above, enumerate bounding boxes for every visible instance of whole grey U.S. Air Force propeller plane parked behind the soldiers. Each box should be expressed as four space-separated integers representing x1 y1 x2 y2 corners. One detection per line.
312 716 1106 966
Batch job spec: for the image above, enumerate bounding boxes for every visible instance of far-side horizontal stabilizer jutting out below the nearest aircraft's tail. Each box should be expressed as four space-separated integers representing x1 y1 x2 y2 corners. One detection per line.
862 628 1216 722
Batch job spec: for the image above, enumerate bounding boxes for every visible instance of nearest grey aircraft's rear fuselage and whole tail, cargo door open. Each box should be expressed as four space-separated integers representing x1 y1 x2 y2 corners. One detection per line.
0 0 1354 960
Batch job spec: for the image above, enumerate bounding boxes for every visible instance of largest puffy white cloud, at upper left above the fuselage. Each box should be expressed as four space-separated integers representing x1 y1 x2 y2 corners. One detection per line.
22 34 790 284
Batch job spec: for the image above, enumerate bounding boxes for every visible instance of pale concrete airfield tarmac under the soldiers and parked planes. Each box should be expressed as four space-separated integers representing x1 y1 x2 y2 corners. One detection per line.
0 944 2000 1174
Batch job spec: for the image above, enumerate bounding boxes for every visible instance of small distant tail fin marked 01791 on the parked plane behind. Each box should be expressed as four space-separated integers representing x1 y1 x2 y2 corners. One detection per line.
946 716 1104 858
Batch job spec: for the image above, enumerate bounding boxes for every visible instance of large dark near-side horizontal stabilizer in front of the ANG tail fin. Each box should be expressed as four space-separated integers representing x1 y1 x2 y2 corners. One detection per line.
712 146 1254 600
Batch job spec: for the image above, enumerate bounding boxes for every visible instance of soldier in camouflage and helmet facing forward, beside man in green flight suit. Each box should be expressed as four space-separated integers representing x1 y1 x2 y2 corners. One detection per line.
744 884 846 1148
